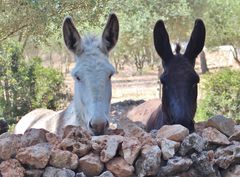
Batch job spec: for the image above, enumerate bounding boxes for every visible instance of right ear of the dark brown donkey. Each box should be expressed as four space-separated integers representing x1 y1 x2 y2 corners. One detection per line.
184 19 206 66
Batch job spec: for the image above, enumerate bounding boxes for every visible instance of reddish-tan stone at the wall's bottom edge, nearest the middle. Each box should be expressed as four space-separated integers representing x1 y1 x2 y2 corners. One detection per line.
106 157 134 177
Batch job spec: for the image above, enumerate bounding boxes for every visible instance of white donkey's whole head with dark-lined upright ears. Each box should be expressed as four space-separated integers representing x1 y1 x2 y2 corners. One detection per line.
63 14 119 135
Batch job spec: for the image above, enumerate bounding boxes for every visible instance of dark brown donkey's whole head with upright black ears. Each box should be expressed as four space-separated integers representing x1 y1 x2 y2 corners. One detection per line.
154 19 205 131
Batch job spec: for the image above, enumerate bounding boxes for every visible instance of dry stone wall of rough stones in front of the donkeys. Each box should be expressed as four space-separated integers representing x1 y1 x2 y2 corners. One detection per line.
0 116 240 177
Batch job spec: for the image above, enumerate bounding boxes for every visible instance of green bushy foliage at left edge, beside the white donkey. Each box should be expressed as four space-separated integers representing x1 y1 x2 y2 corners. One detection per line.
0 42 64 124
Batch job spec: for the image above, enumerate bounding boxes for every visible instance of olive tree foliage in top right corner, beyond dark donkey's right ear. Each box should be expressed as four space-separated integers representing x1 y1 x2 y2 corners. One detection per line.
204 0 240 66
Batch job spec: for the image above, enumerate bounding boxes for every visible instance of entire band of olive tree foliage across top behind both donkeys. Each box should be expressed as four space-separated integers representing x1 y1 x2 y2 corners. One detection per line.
0 0 240 63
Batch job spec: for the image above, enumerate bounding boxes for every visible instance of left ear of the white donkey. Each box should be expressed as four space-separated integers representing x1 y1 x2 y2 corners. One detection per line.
63 17 81 54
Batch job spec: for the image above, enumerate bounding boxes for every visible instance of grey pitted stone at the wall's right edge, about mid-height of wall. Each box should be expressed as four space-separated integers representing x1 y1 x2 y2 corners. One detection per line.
214 144 240 169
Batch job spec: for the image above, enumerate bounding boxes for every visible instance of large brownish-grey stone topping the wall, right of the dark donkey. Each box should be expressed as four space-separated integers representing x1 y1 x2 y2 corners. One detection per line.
207 115 236 136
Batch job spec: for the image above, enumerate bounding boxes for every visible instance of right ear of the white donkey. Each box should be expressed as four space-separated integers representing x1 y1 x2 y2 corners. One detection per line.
102 14 119 51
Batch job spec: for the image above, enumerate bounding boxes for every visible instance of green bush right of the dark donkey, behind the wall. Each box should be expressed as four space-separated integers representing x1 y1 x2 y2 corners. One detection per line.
196 69 240 120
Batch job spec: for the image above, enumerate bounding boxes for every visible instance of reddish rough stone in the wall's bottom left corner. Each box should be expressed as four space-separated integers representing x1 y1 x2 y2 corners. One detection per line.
0 159 25 177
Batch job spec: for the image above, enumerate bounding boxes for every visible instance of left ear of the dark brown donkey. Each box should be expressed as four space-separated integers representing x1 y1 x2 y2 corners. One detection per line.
153 20 173 63
